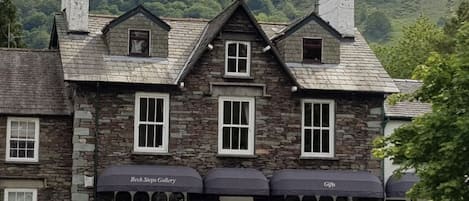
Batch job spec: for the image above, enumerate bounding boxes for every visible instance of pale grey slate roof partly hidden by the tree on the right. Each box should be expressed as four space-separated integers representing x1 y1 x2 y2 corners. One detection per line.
384 79 432 118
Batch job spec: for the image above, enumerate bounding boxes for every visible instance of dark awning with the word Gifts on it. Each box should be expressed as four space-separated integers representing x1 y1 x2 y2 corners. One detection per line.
270 170 384 198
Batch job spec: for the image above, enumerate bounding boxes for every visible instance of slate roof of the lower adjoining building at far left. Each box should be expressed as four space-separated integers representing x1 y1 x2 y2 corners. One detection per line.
0 49 71 115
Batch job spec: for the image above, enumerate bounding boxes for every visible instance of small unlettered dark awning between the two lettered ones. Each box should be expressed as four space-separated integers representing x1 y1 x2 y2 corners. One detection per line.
204 168 269 195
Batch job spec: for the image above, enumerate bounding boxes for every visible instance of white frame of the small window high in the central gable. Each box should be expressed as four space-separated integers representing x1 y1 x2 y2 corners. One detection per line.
225 40 251 77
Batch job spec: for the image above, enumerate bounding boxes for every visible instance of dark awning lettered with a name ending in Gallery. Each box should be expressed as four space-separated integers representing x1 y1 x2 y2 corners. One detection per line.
97 165 203 193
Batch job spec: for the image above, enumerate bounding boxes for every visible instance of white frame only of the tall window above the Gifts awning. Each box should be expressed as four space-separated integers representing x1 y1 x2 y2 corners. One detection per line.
301 99 336 158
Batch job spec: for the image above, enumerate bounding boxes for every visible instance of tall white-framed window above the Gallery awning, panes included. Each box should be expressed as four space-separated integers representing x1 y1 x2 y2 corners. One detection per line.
134 92 169 153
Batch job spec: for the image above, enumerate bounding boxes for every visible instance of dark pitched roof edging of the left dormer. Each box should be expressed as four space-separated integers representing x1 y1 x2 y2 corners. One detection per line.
102 5 171 34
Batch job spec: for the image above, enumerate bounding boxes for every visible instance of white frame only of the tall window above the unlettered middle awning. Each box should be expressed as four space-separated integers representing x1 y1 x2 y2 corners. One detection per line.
218 96 256 156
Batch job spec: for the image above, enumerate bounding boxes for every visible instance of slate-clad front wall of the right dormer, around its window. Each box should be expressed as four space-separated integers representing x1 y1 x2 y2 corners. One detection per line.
277 20 340 64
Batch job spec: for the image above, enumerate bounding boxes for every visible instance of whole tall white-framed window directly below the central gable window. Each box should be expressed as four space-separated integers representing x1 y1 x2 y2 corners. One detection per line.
218 97 255 155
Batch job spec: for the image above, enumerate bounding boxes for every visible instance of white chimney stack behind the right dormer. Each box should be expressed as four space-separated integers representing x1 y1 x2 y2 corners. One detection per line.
315 0 355 37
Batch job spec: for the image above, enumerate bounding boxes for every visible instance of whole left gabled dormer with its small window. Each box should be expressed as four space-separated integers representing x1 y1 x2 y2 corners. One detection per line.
102 5 171 58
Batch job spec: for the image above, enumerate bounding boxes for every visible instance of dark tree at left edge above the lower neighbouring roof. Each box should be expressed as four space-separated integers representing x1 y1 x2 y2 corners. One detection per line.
0 0 24 48
